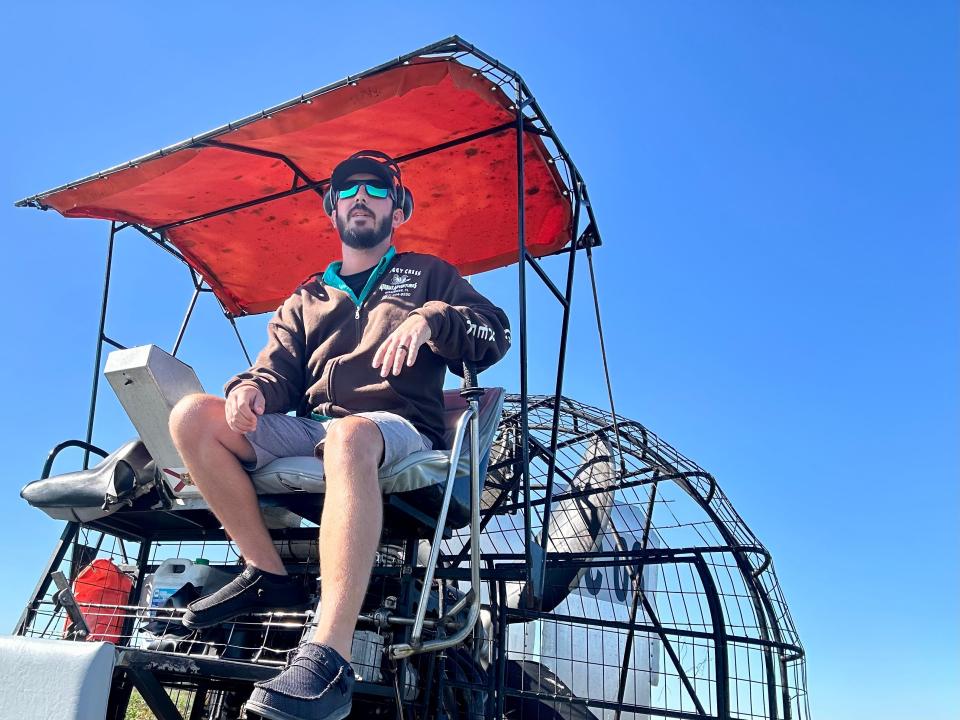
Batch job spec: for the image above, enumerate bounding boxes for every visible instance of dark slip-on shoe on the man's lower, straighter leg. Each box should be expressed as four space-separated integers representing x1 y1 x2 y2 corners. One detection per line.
246 643 356 720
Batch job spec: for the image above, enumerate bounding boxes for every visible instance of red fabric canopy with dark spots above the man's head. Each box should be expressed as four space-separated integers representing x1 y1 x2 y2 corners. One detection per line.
30 58 572 315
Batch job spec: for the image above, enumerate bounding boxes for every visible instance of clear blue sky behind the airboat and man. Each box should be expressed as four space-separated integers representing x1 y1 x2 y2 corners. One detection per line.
0 1 960 720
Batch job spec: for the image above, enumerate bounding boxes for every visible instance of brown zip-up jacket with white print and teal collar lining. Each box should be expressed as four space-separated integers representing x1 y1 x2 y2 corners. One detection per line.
224 253 510 448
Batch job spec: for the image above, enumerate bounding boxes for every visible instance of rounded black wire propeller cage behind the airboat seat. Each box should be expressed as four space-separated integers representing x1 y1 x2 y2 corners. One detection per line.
444 396 809 719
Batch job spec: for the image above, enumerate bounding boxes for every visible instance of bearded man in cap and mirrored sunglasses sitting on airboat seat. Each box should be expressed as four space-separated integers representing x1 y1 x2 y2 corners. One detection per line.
170 151 510 720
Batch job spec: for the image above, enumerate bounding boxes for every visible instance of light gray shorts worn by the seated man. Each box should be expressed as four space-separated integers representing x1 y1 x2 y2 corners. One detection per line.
243 412 433 472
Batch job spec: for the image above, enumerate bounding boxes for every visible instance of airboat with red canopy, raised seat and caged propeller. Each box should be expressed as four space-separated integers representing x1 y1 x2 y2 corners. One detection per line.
7 36 809 720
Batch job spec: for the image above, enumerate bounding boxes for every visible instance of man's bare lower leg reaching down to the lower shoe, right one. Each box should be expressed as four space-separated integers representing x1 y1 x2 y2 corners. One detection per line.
313 417 383 660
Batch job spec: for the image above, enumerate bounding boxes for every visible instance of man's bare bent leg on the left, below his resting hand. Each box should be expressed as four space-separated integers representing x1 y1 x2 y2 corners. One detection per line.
170 394 284 575
